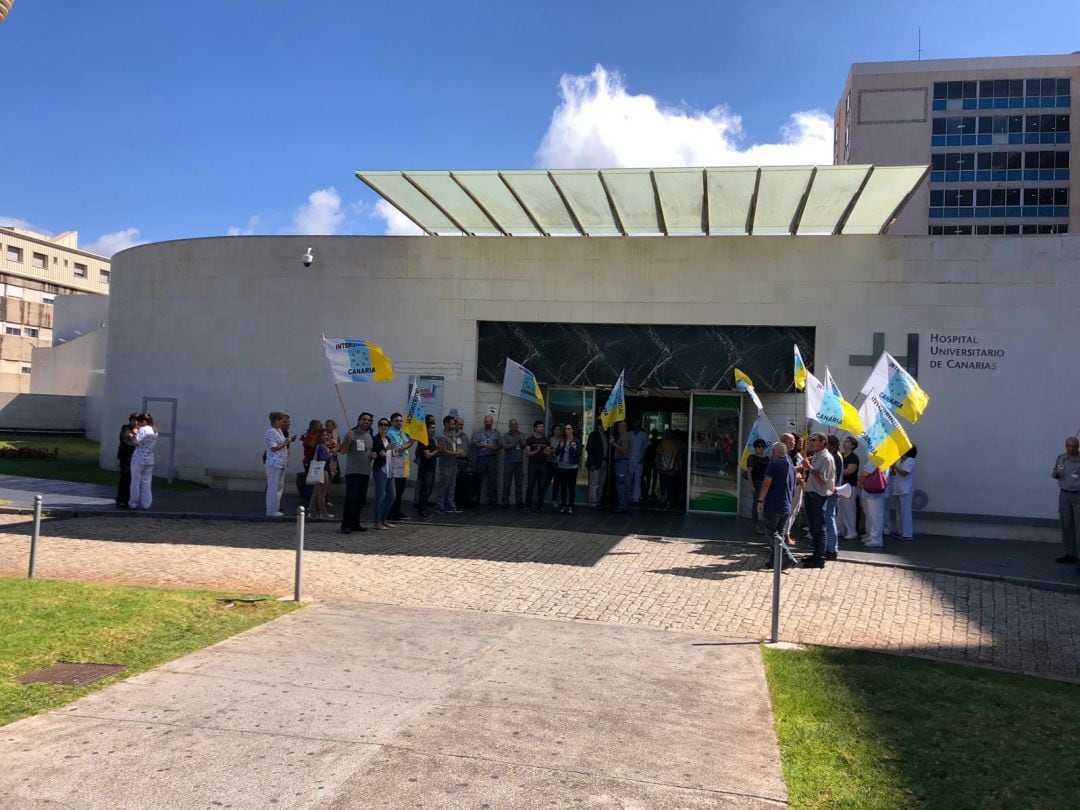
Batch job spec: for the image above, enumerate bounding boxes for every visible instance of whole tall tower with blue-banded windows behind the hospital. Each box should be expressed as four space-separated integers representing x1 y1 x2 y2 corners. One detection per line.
833 53 1080 235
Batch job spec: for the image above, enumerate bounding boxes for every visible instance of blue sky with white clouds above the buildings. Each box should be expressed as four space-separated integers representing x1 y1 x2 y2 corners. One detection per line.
0 0 1080 253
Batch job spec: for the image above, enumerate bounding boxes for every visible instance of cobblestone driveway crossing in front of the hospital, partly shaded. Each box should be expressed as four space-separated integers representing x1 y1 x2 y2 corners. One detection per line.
0 516 1080 679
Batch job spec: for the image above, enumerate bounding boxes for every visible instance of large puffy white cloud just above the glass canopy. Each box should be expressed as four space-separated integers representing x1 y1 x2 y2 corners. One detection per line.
537 65 833 168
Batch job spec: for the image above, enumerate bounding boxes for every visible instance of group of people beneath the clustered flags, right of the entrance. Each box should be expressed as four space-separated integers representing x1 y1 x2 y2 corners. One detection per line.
744 433 919 568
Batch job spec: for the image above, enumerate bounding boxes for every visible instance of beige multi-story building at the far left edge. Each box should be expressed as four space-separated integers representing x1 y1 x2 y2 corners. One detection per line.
0 225 110 393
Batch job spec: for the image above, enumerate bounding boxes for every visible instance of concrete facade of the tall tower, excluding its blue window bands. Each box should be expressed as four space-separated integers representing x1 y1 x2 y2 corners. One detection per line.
833 54 1080 235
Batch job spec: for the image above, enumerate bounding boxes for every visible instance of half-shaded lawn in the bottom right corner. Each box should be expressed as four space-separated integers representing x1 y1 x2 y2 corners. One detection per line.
764 648 1080 810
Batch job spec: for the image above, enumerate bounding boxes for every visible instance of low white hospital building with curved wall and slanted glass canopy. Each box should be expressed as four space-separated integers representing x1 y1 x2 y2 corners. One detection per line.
102 166 1080 537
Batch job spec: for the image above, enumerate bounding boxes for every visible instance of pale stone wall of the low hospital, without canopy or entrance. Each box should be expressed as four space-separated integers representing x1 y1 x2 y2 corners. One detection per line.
102 237 1080 533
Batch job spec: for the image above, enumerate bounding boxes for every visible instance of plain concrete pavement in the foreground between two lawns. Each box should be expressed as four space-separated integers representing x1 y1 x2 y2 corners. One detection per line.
0 604 786 810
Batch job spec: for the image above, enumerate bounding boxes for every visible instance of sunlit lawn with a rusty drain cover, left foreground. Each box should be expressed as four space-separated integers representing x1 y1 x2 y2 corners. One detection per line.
0 579 297 725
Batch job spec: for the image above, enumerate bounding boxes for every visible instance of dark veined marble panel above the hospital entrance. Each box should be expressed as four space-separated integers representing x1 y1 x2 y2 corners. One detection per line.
476 321 814 392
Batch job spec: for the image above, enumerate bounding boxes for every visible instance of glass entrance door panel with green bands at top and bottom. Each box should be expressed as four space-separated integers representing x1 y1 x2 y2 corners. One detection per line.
687 393 742 514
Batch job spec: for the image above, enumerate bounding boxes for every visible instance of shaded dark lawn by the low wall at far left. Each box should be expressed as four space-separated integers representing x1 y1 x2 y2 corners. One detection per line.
0 433 206 492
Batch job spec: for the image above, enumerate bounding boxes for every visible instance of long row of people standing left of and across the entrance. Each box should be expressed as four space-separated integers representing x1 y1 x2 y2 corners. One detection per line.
264 411 687 534
